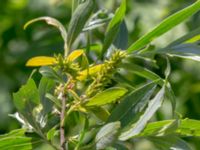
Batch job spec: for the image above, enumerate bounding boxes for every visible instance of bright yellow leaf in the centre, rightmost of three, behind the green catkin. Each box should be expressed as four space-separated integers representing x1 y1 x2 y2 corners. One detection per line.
77 64 104 80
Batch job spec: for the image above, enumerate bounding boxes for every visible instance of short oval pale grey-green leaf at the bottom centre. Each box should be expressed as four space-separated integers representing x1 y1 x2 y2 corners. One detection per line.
95 122 120 150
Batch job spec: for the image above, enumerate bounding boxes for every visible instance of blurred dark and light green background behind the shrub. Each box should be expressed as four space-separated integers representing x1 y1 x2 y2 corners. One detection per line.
0 0 200 149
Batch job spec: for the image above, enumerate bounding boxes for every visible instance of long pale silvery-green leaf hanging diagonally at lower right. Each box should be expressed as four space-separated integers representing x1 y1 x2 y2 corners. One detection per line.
119 86 165 141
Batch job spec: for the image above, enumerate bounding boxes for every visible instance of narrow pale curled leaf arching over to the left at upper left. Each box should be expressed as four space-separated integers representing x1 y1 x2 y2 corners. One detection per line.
24 17 67 49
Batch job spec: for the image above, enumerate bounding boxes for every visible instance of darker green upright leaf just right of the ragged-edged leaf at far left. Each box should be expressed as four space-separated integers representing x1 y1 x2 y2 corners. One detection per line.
38 77 55 114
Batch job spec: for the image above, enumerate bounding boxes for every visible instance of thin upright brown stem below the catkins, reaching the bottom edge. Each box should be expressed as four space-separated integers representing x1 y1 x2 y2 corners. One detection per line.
60 94 66 150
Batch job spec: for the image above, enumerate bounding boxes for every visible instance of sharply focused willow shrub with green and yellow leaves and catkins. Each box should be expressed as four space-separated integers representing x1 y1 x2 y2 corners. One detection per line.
0 0 200 150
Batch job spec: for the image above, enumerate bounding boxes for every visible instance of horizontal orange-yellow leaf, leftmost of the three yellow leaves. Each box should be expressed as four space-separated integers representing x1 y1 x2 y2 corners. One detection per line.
26 56 57 67
